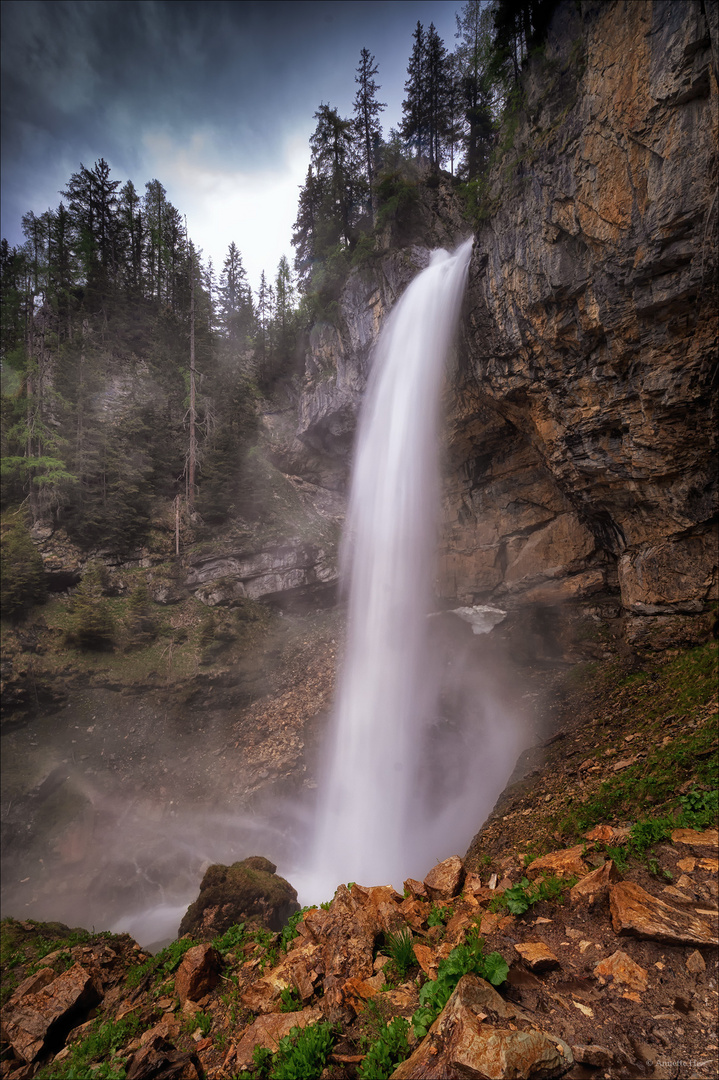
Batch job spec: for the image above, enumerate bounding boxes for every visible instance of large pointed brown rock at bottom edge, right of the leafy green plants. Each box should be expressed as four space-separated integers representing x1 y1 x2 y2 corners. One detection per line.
392 975 574 1080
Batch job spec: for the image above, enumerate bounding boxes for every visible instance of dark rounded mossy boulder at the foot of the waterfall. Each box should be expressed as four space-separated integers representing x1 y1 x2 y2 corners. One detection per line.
178 855 300 941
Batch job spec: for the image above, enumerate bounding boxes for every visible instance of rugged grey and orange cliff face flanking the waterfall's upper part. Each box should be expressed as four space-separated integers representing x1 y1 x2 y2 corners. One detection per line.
300 0 717 639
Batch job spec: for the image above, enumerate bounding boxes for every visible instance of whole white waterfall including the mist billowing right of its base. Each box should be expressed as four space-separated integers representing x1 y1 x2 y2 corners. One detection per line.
290 240 524 902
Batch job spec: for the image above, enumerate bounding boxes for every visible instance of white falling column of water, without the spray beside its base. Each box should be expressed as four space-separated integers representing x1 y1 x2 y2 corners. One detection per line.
300 240 479 895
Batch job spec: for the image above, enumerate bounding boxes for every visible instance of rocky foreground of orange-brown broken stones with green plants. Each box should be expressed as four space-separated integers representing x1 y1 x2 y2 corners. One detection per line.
1 825 719 1080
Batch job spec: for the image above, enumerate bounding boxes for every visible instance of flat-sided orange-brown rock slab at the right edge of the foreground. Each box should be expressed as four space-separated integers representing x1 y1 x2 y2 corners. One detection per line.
609 881 719 945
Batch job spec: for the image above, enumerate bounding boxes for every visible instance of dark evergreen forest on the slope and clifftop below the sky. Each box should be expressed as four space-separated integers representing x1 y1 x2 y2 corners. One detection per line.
0 0 553 591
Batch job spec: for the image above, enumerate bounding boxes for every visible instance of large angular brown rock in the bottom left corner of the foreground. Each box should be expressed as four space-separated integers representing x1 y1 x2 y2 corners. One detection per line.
1 963 103 1063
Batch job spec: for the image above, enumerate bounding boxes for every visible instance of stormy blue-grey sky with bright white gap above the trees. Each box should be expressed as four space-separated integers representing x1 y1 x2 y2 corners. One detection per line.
0 0 461 289
